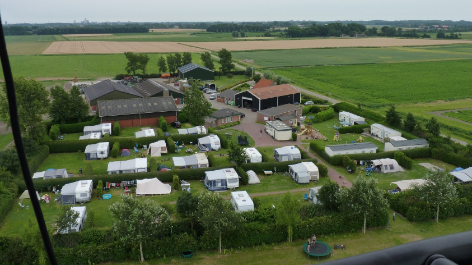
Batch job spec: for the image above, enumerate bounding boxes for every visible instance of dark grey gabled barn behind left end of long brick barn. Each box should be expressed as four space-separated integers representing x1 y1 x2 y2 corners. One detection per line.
84 80 143 111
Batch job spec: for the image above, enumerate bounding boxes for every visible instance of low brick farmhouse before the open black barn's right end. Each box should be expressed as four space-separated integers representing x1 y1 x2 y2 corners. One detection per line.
257 104 302 126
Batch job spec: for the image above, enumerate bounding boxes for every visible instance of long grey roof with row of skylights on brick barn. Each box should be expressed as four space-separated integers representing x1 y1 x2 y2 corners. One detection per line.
98 97 177 117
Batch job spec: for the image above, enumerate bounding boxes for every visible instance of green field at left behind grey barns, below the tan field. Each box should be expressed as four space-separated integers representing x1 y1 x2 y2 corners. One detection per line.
0 53 213 79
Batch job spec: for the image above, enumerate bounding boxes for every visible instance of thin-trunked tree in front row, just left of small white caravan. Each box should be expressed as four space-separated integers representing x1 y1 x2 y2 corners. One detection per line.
198 191 244 252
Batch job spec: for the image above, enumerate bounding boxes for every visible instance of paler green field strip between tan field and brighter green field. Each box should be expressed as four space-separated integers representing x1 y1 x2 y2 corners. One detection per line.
232 44 472 68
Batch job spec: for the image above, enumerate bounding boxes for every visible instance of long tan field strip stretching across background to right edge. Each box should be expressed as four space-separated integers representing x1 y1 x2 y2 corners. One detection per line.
43 38 472 54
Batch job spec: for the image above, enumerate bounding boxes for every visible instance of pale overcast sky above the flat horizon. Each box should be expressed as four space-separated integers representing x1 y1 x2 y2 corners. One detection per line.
0 0 472 24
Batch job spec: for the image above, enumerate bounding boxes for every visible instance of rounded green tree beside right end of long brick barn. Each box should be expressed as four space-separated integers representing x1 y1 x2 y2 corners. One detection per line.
182 83 213 126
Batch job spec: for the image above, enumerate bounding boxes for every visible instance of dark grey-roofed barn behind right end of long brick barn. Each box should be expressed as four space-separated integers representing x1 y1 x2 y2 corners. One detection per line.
133 79 184 104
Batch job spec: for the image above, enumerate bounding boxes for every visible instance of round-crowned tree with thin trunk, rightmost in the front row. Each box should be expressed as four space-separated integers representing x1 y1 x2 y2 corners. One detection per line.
414 170 457 223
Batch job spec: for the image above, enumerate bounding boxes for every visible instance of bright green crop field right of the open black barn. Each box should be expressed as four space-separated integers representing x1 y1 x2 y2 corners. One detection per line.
276 60 472 107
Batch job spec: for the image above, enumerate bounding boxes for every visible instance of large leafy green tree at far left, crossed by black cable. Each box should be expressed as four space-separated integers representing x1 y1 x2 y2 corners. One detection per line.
0 77 49 142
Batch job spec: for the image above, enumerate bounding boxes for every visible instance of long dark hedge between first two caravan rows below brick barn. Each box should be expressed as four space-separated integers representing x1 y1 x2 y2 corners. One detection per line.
44 134 206 153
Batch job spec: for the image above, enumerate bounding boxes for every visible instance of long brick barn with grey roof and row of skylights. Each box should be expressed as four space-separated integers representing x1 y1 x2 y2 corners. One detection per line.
98 97 177 128
